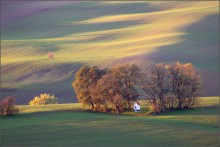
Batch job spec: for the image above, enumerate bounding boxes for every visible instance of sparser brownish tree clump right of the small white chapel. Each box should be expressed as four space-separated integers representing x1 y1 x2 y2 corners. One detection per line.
141 62 201 113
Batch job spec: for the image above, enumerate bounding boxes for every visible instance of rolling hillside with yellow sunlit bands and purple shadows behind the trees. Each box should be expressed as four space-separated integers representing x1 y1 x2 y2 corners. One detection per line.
1 1 219 104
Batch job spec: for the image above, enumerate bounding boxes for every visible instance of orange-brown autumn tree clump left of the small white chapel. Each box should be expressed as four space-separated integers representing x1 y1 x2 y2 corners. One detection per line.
73 65 140 113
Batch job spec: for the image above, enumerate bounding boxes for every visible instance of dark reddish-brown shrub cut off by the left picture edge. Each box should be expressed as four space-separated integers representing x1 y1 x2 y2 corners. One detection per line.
0 96 19 115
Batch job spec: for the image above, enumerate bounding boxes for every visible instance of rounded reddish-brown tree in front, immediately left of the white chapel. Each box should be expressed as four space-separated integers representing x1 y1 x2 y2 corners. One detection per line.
90 73 125 114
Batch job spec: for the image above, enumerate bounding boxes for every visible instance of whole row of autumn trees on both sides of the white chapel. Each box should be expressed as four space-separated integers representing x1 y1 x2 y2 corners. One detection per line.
72 62 201 114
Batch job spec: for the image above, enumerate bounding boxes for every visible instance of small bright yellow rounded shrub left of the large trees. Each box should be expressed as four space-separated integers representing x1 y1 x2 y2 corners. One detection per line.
29 93 58 106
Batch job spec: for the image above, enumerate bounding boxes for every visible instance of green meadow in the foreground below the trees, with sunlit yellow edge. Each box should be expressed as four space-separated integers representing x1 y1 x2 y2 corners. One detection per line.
1 97 220 147
